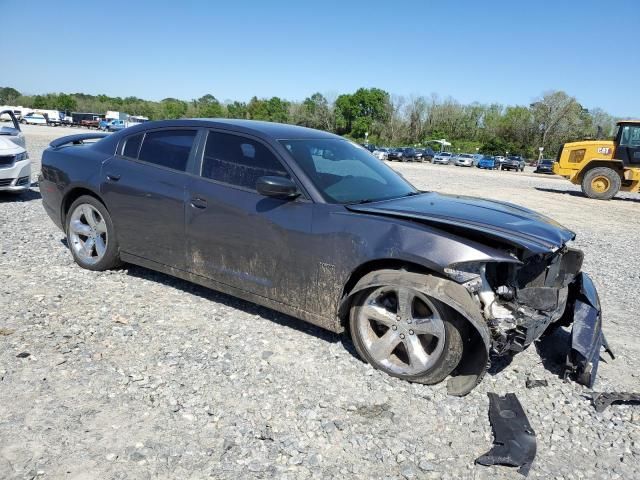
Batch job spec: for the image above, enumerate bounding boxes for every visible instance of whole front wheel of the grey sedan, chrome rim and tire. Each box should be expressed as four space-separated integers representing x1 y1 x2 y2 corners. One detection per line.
349 285 463 384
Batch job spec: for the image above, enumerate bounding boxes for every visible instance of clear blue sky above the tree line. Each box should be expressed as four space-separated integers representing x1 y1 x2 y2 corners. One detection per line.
6 0 640 117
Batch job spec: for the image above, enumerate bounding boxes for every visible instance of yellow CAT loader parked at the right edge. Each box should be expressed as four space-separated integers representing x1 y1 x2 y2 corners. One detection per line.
553 120 640 200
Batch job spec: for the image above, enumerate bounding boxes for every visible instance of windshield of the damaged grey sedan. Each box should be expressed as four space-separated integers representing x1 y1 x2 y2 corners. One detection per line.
280 139 417 203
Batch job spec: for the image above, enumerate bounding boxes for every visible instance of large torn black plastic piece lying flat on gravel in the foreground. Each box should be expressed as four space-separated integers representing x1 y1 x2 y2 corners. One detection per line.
476 393 536 476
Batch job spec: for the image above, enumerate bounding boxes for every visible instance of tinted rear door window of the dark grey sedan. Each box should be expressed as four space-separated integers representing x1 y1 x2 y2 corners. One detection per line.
139 130 196 172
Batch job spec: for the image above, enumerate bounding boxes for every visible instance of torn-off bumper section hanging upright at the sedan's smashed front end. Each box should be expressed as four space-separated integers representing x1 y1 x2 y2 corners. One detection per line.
564 273 613 388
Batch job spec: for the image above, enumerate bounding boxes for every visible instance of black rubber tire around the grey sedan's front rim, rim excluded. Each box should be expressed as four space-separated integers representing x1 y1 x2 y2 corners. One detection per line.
349 284 466 385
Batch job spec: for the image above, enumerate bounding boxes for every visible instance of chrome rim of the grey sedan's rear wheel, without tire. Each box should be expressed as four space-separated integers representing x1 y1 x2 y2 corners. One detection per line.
68 203 109 264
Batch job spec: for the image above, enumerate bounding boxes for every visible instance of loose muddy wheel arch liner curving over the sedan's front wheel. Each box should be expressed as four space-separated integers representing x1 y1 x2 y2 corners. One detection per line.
340 270 491 396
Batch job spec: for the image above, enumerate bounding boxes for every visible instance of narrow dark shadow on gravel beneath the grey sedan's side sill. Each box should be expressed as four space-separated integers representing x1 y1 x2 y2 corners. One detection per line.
127 265 348 346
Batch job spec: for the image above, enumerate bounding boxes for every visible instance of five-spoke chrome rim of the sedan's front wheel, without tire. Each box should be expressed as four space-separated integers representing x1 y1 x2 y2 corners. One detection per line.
356 286 445 375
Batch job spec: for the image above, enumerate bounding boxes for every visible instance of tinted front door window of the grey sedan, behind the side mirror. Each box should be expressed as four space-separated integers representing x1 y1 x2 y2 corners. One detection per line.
202 132 289 190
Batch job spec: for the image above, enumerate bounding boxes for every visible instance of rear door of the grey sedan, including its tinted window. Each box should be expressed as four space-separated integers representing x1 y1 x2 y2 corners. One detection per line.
102 128 198 269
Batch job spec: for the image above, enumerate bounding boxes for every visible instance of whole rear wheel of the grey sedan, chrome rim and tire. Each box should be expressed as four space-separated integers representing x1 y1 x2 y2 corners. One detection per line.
66 195 121 271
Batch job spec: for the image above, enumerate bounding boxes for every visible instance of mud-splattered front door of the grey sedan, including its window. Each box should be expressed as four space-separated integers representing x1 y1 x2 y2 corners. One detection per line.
186 131 314 306
